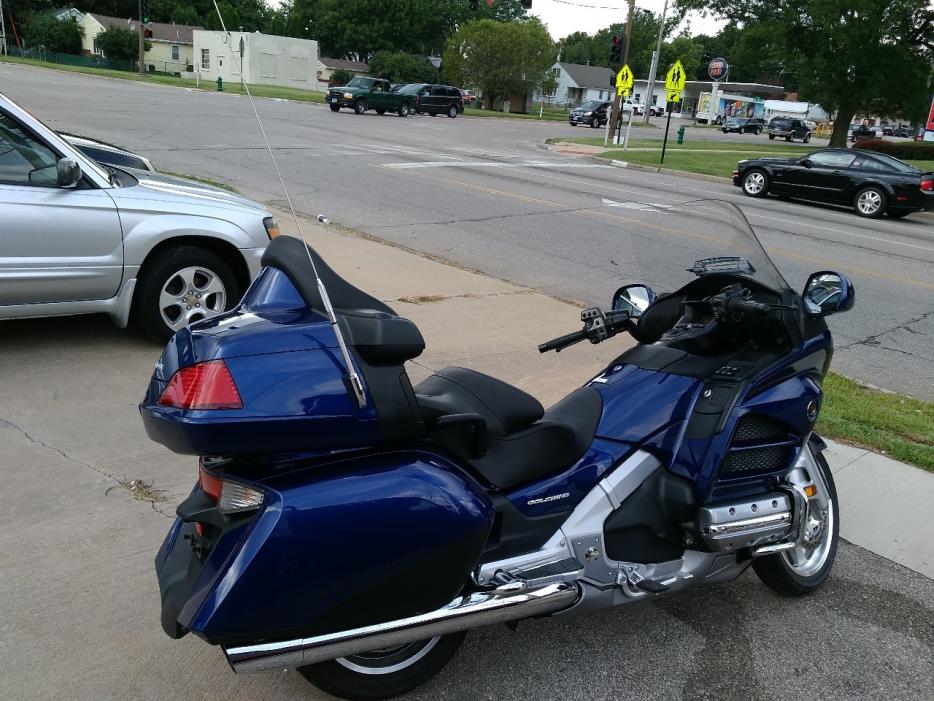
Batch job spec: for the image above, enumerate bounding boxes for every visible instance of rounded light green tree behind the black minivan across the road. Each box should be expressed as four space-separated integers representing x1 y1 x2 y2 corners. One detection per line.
443 18 555 109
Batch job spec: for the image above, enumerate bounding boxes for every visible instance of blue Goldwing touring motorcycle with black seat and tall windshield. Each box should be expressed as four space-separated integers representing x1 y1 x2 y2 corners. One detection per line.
140 202 854 699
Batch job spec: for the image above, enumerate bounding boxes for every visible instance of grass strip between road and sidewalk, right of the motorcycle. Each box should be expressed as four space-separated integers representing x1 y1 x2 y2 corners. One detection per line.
816 373 934 472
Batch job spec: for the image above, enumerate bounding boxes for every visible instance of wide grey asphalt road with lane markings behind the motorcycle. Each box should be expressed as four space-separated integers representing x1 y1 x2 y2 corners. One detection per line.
0 65 934 400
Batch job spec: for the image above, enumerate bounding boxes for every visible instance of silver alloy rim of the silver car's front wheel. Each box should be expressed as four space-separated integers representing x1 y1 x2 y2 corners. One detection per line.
159 265 227 331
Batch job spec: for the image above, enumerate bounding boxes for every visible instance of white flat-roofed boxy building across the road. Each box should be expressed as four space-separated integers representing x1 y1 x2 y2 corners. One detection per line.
194 30 327 90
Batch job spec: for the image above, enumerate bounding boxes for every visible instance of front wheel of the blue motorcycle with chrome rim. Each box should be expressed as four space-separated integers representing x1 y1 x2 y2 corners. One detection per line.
752 446 840 596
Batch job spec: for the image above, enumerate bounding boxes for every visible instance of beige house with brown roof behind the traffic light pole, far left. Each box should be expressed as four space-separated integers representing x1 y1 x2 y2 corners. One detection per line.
78 12 199 73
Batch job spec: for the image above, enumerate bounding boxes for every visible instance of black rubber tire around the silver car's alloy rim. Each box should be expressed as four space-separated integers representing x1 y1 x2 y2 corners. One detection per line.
131 246 242 343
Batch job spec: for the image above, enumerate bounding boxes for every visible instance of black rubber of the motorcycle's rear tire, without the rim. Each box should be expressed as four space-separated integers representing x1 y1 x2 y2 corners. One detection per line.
298 633 466 701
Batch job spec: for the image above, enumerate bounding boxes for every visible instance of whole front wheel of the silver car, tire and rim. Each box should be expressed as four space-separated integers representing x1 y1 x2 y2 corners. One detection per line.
132 246 240 343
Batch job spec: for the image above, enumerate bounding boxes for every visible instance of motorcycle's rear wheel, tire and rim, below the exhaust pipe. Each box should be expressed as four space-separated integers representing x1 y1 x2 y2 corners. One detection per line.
298 633 466 701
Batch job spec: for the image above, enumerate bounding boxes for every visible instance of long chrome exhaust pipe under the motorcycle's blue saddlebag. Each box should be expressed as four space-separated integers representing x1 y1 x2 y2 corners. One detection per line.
224 581 580 672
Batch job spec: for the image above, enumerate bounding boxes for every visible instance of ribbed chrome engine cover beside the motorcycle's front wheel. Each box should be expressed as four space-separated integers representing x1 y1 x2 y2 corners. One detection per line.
698 492 793 552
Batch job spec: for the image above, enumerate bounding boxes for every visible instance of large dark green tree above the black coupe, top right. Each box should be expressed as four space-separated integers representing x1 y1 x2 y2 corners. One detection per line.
679 0 934 146
